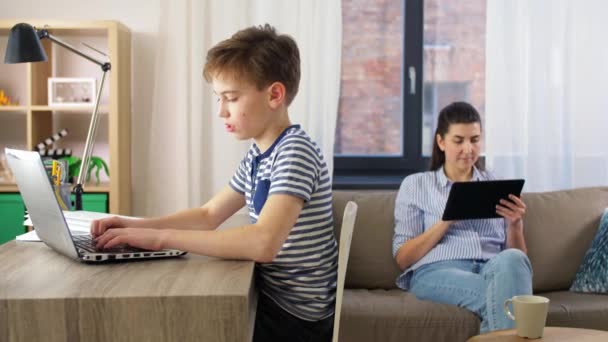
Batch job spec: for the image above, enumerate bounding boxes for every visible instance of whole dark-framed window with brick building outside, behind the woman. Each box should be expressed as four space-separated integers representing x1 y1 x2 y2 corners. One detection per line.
334 0 486 188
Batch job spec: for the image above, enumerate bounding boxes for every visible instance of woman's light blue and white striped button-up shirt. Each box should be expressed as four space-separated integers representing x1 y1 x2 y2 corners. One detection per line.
393 167 506 290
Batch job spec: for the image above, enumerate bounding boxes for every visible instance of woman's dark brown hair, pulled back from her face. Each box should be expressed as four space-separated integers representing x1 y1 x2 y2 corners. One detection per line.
430 102 484 171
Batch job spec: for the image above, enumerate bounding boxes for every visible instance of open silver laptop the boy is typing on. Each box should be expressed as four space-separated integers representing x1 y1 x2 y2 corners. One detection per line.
4 148 186 263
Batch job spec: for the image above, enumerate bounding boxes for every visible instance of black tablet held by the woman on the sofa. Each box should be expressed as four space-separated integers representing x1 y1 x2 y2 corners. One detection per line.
442 179 524 221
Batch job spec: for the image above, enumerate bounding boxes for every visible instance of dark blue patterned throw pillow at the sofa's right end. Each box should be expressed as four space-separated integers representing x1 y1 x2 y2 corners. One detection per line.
570 209 608 293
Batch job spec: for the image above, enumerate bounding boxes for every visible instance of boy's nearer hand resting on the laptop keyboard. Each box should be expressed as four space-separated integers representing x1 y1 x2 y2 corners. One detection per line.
95 228 169 251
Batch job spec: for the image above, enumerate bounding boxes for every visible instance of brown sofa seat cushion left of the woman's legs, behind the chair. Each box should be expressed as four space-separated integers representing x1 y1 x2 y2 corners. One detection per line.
340 289 479 342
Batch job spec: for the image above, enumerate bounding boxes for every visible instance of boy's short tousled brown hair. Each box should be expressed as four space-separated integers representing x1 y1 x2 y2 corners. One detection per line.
203 24 300 106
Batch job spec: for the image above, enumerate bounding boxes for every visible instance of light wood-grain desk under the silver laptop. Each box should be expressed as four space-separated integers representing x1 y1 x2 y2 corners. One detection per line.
0 215 257 342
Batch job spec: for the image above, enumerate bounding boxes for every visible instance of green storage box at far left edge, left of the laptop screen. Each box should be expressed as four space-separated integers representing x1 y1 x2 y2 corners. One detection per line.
0 194 25 244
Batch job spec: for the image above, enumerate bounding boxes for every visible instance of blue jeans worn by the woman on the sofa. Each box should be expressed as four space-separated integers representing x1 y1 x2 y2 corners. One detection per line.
409 249 532 333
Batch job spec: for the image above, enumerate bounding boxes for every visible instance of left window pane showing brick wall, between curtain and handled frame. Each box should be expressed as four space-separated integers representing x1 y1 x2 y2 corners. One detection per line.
335 0 403 156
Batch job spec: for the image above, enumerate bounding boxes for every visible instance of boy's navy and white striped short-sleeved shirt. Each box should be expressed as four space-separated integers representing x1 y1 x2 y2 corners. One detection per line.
230 125 338 321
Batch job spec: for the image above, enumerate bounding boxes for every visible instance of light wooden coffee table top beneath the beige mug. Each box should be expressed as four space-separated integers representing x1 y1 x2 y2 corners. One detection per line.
468 327 608 342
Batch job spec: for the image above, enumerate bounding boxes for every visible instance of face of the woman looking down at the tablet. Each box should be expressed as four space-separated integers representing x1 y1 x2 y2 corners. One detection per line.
436 122 481 172
